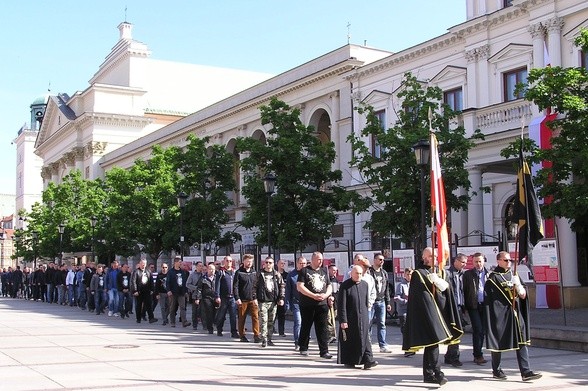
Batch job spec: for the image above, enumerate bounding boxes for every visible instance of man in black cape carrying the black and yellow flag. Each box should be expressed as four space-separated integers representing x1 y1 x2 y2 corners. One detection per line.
484 251 541 381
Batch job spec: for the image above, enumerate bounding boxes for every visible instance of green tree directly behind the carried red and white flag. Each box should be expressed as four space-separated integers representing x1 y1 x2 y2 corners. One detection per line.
348 73 482 247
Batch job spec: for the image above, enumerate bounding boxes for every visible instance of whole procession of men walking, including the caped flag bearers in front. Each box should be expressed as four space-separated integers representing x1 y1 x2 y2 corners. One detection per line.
1 248 541 385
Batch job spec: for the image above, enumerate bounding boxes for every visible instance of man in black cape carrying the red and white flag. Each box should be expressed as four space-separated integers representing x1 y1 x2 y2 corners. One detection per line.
402 247 463 385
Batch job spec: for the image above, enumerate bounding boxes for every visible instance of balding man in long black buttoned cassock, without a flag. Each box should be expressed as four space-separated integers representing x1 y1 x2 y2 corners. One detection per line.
336 265 378 369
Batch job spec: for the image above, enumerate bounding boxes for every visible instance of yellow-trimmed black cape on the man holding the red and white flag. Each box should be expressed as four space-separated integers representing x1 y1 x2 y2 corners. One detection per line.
402 262 463 352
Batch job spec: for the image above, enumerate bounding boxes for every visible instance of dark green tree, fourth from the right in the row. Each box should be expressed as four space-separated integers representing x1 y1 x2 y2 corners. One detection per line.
174 135 239 258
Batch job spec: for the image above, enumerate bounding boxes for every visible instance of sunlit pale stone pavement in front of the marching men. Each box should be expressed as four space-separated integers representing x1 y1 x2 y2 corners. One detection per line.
0 298 588 391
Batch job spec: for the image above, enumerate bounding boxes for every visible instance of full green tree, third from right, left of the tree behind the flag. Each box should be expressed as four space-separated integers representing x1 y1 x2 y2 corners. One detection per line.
237 98 359 251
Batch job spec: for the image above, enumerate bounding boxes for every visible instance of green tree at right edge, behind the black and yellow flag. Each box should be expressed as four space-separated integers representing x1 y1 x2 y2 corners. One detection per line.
502 29 588 230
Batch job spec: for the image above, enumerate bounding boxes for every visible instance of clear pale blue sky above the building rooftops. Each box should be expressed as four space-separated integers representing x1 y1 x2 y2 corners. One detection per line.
0 0 466 194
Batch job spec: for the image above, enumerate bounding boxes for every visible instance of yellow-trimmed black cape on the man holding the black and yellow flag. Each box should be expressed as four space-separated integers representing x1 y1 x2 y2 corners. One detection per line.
484 267 531 352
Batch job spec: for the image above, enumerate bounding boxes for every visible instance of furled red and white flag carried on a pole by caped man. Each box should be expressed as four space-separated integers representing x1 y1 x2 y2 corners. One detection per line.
431 132 449 269
